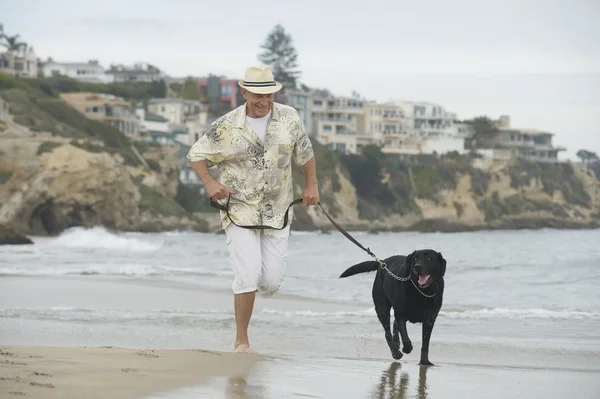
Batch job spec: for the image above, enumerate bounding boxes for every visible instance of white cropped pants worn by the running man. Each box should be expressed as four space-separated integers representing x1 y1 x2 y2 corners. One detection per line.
225 223 290 297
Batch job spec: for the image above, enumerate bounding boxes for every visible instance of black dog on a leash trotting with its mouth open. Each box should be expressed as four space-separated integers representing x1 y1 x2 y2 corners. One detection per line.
340 249 446 366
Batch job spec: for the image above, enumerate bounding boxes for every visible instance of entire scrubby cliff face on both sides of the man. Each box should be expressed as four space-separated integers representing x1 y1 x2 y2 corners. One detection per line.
0 76 600 239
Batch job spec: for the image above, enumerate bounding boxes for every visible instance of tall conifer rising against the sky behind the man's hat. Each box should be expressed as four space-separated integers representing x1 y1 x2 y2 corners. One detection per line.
258 24 300 88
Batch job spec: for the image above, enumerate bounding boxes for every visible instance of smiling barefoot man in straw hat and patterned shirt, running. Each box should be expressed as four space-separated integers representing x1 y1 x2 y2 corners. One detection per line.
188 67 319 353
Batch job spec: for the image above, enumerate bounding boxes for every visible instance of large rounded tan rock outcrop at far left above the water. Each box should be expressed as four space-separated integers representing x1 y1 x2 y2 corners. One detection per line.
0 145 140 235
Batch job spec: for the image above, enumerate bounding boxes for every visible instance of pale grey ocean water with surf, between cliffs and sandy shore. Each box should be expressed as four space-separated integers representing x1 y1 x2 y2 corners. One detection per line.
0 227 600 397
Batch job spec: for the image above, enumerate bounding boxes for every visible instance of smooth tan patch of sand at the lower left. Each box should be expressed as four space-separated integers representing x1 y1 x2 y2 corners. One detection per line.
0 347 259 399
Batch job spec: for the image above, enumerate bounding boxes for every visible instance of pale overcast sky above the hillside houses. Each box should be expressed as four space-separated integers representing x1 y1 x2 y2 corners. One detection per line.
0 0 600 160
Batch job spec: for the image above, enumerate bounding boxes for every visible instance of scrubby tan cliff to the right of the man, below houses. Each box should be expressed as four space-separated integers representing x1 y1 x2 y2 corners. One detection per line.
296 147 600 232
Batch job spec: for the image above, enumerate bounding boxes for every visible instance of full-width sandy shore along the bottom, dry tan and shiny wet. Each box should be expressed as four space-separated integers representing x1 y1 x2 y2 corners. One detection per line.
0 346 600 399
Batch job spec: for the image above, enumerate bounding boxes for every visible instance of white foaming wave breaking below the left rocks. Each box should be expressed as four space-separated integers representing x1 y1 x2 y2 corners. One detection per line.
49 227 162 252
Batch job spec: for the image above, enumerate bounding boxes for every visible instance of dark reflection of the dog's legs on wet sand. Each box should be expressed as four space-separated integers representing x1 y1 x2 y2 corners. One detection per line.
371 362 429 399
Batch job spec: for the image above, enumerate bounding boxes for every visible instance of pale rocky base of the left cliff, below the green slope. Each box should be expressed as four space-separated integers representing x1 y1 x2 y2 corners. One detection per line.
0 138 207 235
